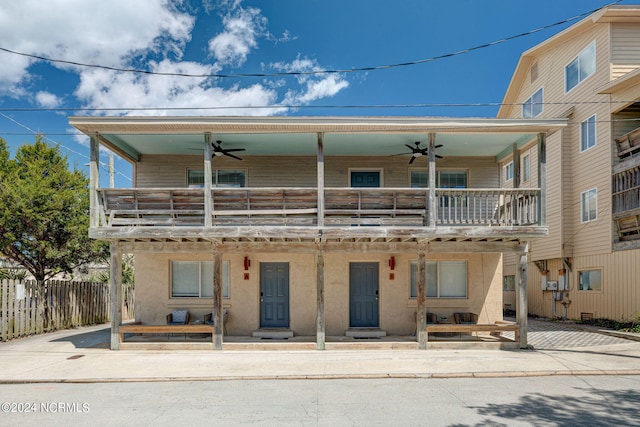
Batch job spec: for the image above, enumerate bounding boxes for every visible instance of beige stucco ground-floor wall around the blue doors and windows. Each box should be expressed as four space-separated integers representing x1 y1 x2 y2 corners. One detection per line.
135 251 502 336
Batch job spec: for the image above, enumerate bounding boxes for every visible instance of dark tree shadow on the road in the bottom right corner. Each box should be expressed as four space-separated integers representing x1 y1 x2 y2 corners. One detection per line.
454 388 640 426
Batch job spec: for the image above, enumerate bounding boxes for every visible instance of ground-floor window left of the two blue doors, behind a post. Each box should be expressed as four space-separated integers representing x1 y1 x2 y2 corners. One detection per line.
171 261 229 298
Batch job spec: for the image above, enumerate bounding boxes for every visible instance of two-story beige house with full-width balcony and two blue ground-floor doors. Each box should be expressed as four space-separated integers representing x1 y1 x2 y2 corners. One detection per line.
70 117 566 349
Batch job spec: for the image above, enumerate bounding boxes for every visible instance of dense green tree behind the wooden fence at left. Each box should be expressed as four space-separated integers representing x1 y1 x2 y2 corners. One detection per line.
0 136 106 283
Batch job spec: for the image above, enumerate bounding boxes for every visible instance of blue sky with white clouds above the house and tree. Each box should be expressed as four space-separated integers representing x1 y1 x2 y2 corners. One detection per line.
0 0 633 187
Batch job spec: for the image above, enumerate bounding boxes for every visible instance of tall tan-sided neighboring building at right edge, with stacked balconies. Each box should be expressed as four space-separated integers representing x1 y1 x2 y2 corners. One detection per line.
498 5 640 321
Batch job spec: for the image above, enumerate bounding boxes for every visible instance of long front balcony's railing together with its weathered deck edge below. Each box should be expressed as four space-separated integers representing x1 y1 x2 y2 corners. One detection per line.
92 187 546 244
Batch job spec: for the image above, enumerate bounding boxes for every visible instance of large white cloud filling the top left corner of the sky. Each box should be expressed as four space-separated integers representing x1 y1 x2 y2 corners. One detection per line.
0 0 194 94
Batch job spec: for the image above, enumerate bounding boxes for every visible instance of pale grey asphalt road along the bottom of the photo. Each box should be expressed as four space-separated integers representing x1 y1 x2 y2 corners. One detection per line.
0 375 640 427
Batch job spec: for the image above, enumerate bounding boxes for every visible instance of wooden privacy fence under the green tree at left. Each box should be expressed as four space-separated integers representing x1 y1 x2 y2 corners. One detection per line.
0 280 135 341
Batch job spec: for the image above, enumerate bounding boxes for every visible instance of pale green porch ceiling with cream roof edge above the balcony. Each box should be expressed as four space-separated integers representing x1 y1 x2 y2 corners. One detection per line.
69 117 566 160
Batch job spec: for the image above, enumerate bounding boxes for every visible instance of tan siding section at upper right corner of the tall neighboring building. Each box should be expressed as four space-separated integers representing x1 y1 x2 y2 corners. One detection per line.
611 23 640 80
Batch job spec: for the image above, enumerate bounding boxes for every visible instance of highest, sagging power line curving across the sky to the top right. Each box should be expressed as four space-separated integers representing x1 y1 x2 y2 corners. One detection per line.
0 0 622 78
